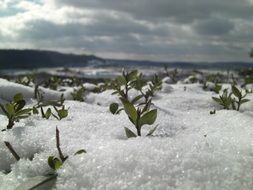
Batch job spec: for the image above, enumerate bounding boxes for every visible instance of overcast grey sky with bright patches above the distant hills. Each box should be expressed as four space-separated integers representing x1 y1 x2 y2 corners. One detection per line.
0 0 253 61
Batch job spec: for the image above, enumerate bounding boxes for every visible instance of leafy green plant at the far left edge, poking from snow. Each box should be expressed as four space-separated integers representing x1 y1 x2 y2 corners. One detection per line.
0 93 32 129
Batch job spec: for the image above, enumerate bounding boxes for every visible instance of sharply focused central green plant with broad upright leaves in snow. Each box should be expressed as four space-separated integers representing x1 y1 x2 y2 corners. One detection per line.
120 98 157 138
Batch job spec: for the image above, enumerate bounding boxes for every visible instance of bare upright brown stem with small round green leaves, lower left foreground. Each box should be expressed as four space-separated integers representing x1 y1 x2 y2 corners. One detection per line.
48 127 86 170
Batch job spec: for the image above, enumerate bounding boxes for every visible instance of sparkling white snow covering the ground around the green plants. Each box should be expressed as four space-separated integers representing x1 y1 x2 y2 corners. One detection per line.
0 79 253 190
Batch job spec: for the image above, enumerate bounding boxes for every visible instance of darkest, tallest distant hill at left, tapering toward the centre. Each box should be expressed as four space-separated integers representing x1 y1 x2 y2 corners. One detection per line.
0 50 105 69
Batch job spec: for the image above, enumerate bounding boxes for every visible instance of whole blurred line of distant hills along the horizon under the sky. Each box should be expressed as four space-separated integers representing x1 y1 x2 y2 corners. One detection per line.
0 49 253 70
